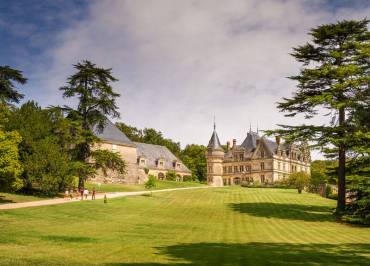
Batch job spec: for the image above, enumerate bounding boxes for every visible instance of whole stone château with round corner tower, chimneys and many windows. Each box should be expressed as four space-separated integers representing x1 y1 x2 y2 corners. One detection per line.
206 126 311 186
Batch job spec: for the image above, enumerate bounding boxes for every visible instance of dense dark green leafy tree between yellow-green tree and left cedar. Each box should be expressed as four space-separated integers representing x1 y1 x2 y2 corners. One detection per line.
5 101 73 195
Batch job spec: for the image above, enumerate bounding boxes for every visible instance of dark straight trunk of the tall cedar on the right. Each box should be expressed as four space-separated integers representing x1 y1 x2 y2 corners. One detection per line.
337 108 346 212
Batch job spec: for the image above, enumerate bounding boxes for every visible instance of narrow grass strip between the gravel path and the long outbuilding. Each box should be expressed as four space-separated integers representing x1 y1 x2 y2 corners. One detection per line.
85 180 204 192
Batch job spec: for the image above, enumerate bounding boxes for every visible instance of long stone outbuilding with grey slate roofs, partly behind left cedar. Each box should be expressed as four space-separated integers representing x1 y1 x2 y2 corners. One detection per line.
92 120 191 184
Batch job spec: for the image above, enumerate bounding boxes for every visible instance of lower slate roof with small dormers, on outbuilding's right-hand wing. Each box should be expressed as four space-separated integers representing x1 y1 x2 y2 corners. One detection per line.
134 142 191 173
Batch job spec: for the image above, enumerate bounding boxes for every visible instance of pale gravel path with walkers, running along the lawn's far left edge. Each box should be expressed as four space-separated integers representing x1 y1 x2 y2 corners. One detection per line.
0 186 208 210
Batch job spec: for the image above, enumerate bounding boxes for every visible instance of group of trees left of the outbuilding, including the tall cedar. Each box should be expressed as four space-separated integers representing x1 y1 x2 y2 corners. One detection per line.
0 61 125 195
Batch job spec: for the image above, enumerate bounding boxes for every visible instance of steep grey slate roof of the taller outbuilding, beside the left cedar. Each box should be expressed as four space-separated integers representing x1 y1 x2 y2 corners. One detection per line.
93 119 135 146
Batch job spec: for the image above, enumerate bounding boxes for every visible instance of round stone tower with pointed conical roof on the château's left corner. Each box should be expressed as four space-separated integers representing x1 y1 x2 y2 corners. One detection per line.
206 125 225 187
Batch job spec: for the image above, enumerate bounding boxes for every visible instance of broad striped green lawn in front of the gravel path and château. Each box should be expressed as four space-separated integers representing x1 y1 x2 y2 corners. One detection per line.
0 187 370 265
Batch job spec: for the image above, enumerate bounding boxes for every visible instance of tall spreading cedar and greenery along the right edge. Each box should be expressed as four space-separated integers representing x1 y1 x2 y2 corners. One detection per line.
268 19 370 223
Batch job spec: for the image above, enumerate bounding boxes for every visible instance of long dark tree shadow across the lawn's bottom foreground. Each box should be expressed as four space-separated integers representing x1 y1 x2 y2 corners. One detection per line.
107 242 370 265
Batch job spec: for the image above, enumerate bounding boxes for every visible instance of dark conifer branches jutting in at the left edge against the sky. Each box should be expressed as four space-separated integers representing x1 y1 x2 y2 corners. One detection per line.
0 66 27 104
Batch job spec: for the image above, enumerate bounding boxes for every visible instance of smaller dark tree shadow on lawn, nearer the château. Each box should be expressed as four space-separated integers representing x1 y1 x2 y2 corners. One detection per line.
229 202 335 222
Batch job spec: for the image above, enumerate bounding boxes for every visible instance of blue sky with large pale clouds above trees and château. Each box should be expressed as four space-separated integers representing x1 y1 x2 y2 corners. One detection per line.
0 0 370 158
